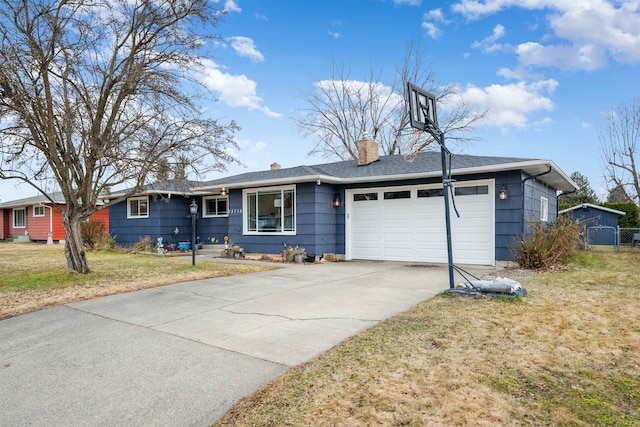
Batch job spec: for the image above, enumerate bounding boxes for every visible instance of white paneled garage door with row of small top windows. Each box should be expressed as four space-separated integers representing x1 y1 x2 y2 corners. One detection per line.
346 181 495 265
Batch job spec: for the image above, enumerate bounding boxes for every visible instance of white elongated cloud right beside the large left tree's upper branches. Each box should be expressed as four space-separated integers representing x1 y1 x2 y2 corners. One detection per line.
201 59 281 117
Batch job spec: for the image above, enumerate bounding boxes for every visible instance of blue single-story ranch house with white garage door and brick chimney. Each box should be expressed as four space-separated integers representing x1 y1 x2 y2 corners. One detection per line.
109 138 576 265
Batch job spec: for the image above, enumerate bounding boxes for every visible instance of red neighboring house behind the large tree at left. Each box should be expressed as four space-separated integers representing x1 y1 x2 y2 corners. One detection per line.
0 193 109 242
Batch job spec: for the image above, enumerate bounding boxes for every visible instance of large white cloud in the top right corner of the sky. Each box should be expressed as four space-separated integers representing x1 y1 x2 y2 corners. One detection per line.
452 0 640 70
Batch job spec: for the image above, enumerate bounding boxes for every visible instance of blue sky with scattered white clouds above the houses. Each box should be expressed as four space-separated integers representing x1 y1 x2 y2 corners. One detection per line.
0 0 640 201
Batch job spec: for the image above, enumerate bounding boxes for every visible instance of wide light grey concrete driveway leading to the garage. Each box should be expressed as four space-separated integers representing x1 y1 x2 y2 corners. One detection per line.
0 262 496 426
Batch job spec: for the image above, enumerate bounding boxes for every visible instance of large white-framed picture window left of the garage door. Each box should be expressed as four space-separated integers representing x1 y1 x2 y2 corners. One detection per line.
244 186 296 234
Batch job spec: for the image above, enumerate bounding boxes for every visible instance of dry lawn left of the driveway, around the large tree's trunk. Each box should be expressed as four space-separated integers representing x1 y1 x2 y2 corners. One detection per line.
0 243 272 319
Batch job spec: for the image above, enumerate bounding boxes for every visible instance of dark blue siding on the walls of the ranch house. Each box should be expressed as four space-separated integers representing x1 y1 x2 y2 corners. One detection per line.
109 171 557 260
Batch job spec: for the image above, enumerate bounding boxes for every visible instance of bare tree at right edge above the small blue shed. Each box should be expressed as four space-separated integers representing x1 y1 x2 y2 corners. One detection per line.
599 98 640 204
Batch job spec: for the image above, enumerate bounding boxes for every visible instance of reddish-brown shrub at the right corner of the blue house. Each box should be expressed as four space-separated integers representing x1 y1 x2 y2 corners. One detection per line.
513 216 580 269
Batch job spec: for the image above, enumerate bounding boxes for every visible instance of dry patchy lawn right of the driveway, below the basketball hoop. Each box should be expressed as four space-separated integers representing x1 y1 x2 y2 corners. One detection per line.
216 253 640 426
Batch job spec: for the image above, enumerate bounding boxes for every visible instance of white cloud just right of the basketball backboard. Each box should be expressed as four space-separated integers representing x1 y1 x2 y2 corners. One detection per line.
461 79 558 128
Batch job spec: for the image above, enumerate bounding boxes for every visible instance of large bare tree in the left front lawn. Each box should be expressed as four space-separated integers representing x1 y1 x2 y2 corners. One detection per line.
0 0 236 273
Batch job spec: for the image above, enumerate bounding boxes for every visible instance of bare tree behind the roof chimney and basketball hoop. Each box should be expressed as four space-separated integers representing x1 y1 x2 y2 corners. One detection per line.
295 43 487 160
